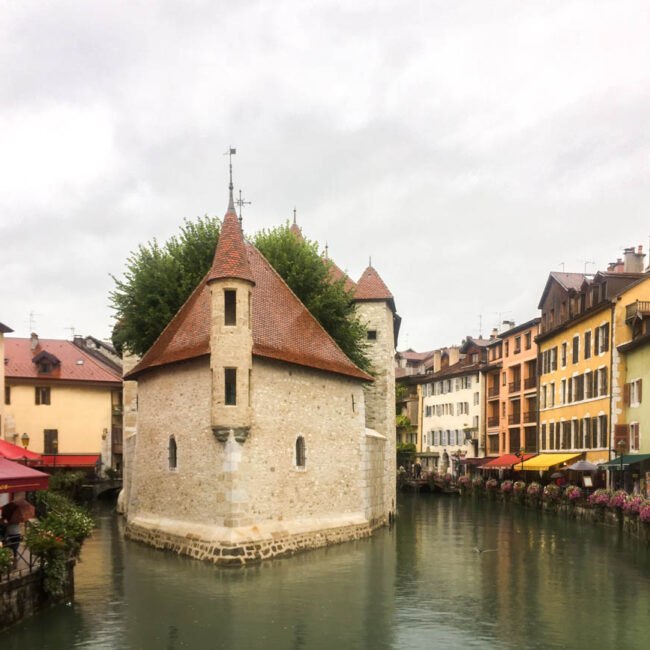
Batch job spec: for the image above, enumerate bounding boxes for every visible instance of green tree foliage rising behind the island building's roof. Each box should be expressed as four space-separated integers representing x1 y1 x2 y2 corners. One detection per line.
110 217 370 370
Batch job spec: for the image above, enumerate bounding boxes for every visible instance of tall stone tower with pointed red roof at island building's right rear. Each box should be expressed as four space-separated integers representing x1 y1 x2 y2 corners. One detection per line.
354 265 401 513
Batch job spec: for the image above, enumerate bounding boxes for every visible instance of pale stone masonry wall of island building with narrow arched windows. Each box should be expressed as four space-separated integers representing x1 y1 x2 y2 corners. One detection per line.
127 357 394 557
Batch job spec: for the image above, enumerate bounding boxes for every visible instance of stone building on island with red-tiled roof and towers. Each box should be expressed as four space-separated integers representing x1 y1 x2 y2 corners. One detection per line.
122 184 399 564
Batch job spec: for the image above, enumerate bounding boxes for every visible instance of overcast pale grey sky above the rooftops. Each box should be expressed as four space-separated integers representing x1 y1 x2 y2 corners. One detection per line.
0 0 650 350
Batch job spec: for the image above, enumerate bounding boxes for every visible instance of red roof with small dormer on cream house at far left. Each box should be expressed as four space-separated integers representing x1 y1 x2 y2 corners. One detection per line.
5 337 122 384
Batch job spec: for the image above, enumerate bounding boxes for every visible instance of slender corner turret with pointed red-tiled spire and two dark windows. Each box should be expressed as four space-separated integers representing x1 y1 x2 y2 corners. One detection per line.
207 185 255 443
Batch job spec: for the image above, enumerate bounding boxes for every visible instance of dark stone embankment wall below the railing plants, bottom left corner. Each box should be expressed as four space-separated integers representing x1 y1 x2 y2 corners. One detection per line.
0 562 74 630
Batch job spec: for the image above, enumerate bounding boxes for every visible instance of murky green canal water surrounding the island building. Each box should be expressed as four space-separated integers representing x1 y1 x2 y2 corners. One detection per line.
0 494 650 650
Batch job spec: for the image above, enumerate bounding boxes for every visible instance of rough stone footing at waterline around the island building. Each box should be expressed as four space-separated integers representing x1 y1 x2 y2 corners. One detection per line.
126 517 386 565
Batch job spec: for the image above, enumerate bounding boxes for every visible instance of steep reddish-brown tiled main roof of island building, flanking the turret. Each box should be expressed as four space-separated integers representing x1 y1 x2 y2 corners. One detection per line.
126 240 371 381
